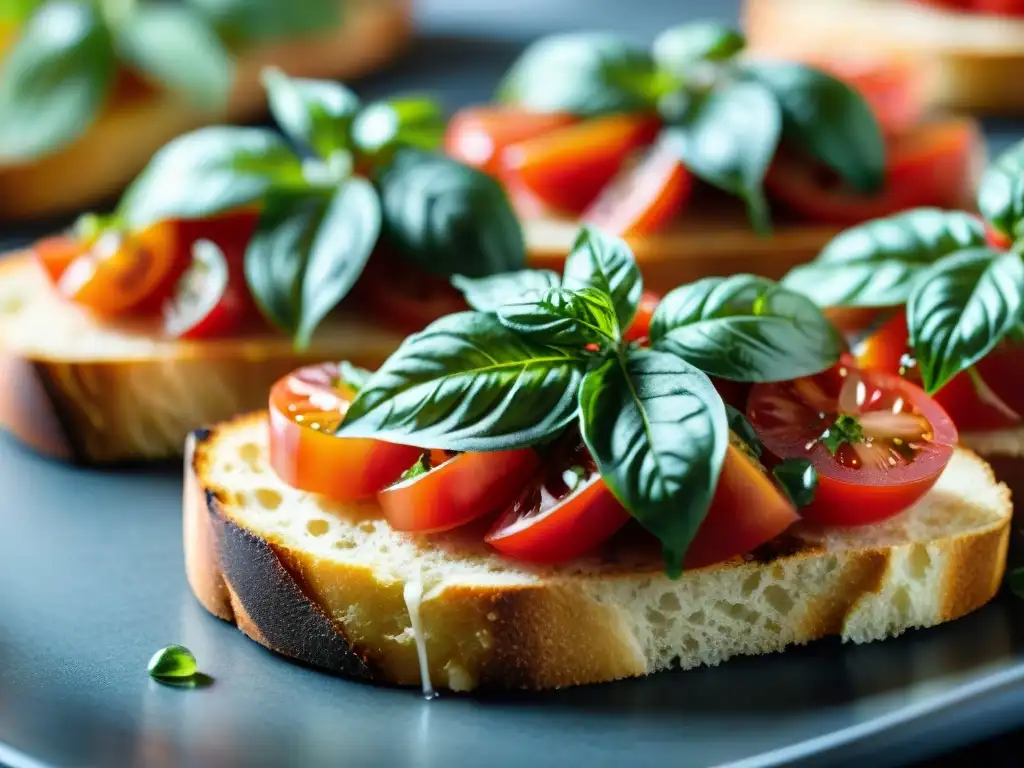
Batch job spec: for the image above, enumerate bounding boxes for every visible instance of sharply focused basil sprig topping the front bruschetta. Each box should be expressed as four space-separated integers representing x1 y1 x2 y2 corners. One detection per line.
338 227 840 573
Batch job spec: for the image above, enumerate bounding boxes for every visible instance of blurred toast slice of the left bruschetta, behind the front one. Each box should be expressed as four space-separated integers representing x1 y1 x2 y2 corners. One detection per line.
0 254 402 463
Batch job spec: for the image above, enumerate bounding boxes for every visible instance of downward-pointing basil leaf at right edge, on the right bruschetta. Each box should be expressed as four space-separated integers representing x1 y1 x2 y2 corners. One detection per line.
906 248 1024 394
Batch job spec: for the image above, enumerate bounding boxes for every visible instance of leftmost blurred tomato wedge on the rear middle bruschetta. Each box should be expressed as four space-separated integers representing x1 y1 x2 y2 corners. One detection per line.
444 106 577 175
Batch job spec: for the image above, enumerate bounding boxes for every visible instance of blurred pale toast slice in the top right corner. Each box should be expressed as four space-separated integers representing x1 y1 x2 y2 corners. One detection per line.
744 0 1024 113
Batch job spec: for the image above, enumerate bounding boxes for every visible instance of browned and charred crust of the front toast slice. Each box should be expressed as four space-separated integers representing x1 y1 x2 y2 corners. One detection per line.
183 413 1011 689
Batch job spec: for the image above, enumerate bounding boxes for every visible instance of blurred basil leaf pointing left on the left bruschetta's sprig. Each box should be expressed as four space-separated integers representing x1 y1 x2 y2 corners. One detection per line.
118 126 305 228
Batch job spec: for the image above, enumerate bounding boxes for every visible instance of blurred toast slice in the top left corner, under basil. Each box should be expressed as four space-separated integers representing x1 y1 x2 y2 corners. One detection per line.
0 0 412 219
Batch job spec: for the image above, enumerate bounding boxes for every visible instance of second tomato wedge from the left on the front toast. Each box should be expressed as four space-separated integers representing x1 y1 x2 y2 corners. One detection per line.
377 449 541 534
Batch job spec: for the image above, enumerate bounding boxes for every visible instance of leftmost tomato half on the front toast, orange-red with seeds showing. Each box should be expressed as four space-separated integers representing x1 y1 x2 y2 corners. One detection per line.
269 362 420 501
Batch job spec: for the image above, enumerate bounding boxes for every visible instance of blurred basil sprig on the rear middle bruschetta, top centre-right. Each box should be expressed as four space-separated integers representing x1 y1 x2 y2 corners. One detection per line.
498 22 885 232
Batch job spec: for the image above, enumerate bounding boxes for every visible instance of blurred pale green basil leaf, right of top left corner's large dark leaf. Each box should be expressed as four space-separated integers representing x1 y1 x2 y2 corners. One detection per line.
116 4 234 110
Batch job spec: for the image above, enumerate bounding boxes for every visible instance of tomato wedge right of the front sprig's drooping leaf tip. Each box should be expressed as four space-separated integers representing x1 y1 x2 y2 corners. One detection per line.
684 445 800 568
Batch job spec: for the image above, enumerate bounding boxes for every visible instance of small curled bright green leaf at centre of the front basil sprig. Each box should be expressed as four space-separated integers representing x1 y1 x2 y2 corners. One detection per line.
498 288 622 346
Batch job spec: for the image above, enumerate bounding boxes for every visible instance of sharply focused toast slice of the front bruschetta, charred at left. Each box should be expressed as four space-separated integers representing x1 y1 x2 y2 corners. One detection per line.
184 412 1011 690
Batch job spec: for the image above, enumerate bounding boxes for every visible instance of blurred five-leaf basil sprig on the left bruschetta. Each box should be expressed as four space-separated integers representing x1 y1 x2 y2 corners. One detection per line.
118 70 525 349
